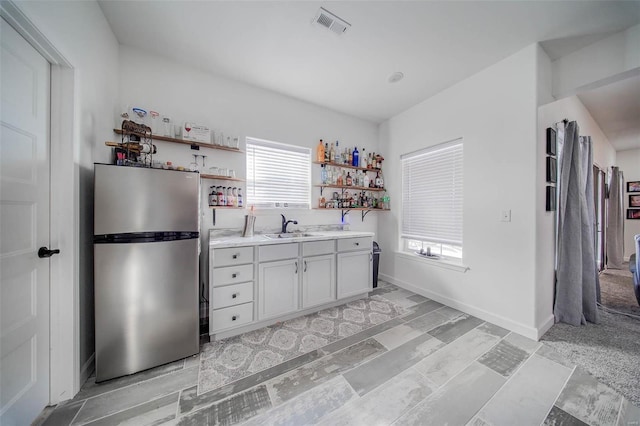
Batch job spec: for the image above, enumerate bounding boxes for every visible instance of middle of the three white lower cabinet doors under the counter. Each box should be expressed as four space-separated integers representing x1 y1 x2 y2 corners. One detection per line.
302 254 336 308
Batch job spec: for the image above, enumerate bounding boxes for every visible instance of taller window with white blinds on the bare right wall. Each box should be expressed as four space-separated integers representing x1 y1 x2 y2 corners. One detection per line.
400 139 463 259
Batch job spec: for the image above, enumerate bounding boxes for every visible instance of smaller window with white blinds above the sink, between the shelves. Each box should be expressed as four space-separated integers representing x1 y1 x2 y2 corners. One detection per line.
246 138 311 209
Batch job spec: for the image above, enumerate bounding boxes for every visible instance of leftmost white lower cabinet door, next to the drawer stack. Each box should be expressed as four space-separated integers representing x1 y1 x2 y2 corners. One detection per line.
258 259 300 320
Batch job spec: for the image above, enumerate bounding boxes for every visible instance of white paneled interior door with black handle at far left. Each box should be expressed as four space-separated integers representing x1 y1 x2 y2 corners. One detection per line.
0 19 50 425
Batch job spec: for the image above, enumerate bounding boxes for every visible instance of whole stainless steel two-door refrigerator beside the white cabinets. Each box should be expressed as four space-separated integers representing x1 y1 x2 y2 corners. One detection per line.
93 164 200 382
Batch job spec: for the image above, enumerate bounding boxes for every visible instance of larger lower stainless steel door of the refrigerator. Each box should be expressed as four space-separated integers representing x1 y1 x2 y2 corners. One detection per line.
94 239 199 382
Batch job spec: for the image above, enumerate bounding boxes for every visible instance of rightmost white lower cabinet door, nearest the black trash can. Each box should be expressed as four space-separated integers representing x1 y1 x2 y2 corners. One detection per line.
337 251 373 299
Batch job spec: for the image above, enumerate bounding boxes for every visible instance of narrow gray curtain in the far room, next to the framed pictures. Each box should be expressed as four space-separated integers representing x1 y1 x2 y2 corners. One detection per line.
607 167 624 269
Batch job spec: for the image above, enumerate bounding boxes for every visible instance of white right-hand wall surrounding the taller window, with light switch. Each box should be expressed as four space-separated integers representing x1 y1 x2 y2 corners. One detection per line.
379 45 548 338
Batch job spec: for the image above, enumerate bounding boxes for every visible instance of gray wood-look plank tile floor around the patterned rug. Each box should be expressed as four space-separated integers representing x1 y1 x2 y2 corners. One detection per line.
42 283 640 426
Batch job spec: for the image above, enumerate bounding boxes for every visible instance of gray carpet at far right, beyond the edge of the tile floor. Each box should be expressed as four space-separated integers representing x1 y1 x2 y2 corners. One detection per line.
541 271 640 406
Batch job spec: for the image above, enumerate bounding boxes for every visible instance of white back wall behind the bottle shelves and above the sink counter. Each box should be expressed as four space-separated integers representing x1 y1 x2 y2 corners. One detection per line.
118 46 385 302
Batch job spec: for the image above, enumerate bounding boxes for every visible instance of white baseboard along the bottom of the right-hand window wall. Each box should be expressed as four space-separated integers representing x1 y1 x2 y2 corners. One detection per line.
380 273 546 341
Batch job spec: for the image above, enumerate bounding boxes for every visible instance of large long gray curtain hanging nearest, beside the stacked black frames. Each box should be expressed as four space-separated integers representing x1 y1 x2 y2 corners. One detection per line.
553 121 598 325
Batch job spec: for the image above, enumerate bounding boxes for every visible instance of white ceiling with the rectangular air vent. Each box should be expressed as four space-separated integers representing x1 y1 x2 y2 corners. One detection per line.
99 0 640 122
